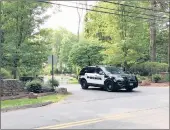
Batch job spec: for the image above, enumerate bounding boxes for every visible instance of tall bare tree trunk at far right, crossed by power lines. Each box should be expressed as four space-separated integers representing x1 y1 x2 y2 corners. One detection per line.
150 0 156 62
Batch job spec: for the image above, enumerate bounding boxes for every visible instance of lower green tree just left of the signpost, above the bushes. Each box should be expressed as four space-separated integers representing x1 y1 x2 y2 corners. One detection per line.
19 29 53 76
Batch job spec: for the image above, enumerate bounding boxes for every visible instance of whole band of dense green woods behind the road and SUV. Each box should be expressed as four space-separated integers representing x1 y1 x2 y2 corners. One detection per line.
1 0 169 78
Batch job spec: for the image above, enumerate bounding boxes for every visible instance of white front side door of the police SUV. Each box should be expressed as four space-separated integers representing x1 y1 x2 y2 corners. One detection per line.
95 68 105 85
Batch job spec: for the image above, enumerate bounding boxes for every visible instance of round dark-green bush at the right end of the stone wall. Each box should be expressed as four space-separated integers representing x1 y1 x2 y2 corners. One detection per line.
26 79 43 93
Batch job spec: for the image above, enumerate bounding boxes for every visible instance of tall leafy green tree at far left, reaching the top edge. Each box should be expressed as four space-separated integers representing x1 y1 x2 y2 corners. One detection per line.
2 0 49 78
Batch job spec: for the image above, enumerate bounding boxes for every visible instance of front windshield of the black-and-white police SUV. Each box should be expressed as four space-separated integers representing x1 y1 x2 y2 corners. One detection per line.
103 66 124 74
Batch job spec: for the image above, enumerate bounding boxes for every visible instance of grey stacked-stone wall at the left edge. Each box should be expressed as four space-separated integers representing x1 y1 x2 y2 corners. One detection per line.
0 79 24 96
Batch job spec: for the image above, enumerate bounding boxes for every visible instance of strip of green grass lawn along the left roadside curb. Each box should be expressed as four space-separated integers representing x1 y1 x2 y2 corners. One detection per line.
1 94 68 108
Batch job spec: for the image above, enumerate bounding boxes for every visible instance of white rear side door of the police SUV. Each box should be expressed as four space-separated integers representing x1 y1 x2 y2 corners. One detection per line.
85 67 95 84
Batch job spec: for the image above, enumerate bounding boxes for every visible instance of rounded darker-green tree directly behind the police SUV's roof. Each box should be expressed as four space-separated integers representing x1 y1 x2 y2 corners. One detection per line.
69 40 103 67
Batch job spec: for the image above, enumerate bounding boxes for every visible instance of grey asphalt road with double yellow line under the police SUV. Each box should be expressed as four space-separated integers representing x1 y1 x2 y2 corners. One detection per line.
1 85 169 129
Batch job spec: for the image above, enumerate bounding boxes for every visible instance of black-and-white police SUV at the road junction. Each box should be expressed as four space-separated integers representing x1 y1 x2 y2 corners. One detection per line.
79 66 138 92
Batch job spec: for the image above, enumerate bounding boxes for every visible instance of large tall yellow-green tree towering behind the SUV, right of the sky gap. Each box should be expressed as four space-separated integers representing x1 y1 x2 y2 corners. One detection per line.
85 1 149 68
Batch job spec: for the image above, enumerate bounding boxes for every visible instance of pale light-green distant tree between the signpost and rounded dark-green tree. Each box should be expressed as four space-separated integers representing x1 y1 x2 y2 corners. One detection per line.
51 27 77 72
